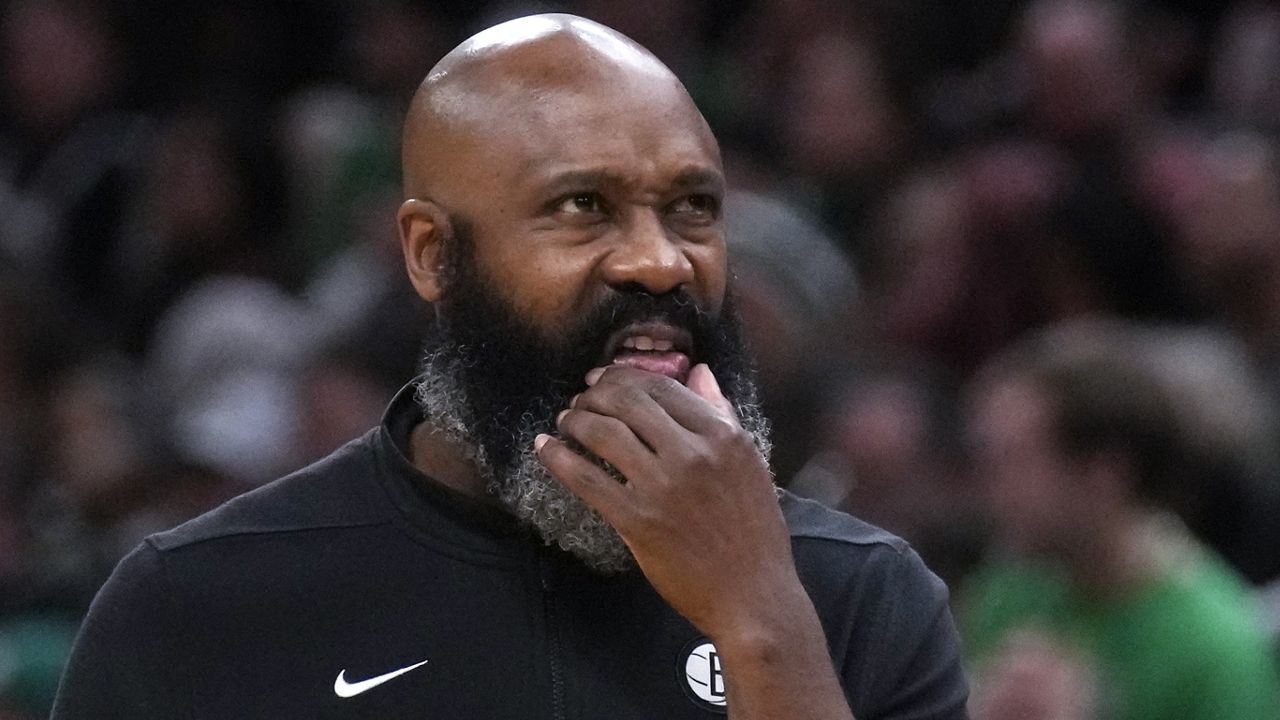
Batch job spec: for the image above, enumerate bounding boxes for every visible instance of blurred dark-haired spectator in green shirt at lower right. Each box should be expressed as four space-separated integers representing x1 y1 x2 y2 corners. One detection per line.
961 320 1280 720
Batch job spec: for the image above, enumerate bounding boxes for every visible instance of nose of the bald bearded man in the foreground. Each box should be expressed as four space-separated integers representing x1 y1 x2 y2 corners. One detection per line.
603 211 694 295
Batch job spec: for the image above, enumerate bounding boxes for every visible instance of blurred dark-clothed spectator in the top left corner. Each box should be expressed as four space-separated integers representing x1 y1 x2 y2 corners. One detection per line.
0 0 150 342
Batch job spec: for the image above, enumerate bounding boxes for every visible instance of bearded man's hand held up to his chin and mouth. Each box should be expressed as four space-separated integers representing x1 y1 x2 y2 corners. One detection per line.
538 364 808 632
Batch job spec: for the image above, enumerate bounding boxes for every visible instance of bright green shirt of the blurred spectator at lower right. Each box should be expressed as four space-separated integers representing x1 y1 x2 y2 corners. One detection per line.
961 540 1280 720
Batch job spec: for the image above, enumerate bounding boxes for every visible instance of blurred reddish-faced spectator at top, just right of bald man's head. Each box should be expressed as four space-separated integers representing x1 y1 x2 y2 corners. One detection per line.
710 0 914 252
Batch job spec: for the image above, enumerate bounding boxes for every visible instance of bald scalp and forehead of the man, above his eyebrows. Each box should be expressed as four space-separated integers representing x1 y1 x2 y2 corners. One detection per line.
404 15 719 200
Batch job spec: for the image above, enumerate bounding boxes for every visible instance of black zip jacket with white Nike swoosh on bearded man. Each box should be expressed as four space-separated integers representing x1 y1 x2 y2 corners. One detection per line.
52 384 966 720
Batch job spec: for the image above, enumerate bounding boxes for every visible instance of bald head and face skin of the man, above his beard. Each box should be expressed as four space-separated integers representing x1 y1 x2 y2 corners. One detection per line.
398 10 724 316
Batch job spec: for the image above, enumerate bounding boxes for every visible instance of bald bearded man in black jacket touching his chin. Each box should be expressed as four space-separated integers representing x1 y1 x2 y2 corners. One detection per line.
54 15 966 719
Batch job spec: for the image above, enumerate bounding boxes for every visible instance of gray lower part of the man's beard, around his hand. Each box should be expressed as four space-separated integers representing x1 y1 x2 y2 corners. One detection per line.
415 350 772 575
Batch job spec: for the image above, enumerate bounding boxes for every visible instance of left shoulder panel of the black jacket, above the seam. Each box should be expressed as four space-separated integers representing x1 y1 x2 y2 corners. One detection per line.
147 430 392 552
